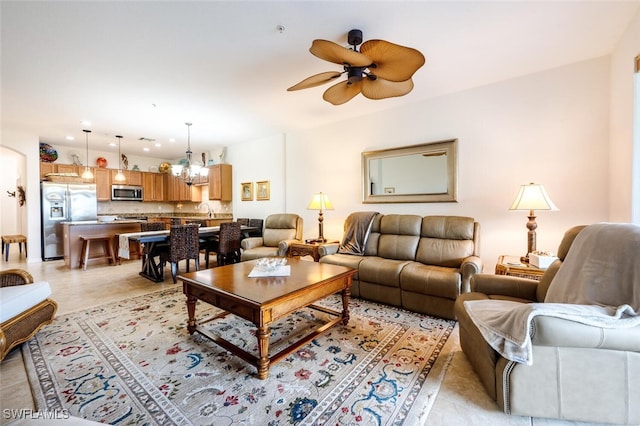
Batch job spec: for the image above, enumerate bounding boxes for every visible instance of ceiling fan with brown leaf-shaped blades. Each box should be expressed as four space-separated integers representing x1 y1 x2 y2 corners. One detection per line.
287 30 425 105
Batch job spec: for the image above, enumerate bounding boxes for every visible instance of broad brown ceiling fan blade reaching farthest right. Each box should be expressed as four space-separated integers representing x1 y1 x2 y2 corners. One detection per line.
360 40 425 81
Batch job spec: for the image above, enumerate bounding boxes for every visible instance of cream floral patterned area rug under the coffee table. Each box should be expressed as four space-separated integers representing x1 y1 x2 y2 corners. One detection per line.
23 288 455 426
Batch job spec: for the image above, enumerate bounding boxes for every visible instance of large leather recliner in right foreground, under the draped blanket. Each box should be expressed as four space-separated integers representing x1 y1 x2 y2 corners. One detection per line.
455 226 640 424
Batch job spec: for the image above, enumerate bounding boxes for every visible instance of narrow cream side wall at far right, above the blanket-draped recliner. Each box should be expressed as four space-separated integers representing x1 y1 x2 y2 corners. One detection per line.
609 12 640 223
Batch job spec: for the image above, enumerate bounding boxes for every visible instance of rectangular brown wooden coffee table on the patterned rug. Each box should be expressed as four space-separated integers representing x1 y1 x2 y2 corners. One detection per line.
178 259 356 379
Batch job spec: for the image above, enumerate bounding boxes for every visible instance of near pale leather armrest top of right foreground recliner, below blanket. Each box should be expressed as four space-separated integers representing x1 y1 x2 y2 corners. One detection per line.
531 315 640 352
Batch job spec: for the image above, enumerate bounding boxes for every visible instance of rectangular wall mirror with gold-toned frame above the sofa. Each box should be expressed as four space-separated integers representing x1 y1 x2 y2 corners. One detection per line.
362 139 458 203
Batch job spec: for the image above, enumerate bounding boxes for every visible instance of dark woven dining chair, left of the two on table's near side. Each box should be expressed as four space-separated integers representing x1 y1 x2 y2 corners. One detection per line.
160 224 200 284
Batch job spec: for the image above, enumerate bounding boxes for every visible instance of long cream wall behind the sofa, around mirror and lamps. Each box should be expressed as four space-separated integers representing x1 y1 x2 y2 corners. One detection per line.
229 57 610 271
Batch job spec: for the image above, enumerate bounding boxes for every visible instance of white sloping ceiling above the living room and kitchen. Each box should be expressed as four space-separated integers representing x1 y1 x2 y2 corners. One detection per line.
1 0 640 158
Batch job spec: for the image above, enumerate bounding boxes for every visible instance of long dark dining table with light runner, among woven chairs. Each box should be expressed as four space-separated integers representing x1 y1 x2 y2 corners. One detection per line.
118 225 257 282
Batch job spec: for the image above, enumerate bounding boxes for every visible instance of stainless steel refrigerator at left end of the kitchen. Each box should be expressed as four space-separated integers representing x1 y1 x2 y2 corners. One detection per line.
40 182 98 260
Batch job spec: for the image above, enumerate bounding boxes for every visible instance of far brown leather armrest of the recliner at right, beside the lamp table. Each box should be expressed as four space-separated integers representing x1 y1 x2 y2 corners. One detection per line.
471 274 538 302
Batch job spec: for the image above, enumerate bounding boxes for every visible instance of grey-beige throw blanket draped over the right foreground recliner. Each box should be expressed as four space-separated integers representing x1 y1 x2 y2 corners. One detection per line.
464 223 640 365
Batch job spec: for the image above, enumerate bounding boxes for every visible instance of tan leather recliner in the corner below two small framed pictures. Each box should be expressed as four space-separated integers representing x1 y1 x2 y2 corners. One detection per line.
241 213 303 262
